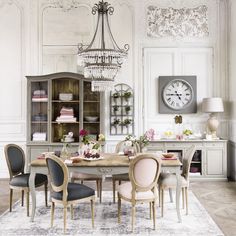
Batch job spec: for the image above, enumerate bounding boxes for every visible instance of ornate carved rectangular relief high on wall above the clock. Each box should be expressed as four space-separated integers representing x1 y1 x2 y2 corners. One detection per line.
147 5 209 38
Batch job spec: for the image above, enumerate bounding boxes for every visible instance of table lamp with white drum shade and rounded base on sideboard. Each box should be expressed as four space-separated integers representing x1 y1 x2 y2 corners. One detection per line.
202 97 224 139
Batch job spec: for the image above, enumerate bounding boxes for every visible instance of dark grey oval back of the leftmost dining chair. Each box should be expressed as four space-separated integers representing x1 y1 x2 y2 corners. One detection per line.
4 144 25 180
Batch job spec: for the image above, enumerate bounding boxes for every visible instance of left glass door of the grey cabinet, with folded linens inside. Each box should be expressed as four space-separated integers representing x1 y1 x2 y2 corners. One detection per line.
30 81 48 142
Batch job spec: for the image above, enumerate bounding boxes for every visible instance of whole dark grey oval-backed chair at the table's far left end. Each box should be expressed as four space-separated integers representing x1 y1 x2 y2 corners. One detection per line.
4 144 48 216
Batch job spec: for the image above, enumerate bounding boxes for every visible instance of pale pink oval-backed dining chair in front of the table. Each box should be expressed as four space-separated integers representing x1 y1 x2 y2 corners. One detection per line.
117 153 161 231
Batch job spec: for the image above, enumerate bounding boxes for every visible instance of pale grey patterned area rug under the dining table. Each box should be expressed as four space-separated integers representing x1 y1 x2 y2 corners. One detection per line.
0 191 224 236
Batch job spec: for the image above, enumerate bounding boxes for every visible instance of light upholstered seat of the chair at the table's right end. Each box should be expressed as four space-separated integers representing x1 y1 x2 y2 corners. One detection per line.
158 173 188 188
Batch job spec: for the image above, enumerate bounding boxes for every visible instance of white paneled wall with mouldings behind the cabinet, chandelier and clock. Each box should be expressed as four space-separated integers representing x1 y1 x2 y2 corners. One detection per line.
0 0 231 177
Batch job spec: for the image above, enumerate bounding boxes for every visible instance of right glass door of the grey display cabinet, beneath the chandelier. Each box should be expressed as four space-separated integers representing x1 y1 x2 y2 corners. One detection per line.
83 82 100 139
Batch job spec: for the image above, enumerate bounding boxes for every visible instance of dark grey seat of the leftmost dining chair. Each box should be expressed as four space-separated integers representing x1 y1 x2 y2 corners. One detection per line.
10 173 47 187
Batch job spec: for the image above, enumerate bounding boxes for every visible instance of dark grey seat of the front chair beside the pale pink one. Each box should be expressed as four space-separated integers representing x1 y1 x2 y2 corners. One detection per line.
51 183 95 201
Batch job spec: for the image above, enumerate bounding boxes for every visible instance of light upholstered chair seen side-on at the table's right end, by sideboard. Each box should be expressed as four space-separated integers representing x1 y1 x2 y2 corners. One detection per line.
158 145 196 217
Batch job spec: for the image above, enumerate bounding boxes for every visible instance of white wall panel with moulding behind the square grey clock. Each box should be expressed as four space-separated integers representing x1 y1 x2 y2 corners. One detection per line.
143 48 213 132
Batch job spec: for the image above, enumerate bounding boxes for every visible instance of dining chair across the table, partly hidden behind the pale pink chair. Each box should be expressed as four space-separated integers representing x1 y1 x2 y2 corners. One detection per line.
112 140 140 203
